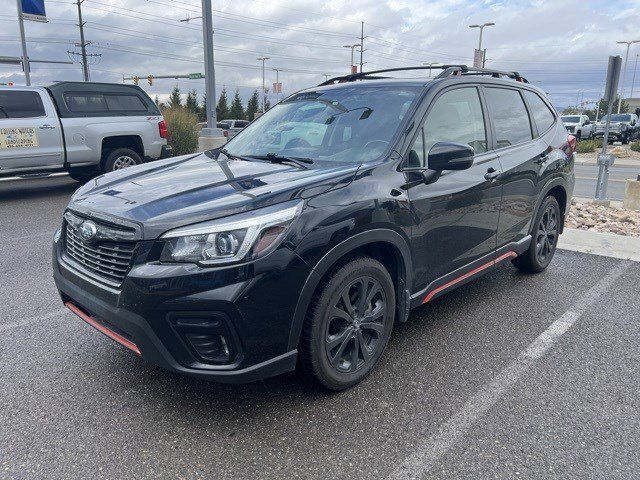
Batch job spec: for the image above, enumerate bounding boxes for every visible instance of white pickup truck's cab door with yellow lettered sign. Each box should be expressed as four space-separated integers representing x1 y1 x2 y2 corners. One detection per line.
0 88 64 173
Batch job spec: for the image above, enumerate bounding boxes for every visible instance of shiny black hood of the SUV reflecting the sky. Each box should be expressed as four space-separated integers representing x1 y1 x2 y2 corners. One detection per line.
69 154 359 239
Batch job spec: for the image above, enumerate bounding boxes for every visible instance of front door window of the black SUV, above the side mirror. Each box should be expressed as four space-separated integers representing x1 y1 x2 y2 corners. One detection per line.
424 88 487 154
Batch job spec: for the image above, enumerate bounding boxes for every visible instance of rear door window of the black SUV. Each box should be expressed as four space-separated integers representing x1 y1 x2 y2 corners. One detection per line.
485 88 533 148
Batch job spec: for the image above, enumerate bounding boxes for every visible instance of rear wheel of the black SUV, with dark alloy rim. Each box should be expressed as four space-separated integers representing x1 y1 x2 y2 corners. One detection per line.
512 196 564 273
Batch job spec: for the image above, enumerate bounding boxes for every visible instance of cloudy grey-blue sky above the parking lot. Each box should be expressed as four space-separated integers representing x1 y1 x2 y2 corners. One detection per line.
0 0 640 107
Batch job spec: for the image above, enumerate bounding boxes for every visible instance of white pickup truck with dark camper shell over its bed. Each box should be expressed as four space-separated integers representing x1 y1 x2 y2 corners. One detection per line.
0 82 171 181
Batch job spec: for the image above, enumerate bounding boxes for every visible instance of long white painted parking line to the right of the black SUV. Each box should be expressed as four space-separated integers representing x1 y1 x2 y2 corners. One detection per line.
388 261 633 480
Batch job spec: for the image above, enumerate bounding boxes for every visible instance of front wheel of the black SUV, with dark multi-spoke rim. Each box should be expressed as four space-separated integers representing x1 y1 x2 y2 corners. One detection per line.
299 257 396 391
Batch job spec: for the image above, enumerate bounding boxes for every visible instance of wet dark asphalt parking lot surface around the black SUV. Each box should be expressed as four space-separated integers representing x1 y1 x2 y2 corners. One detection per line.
0 177 640 479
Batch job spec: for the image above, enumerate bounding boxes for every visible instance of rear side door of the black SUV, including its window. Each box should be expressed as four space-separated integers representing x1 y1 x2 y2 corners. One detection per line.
483 86 554 247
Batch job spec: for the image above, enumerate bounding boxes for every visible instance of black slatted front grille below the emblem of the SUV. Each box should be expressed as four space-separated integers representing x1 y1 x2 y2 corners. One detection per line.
65 219 136 288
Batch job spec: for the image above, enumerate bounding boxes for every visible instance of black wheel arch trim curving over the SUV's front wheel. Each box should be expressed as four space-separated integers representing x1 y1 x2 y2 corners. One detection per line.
289 229 413 350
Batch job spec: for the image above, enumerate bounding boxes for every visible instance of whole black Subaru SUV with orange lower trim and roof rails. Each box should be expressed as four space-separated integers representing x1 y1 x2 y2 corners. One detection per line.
53 65 575 390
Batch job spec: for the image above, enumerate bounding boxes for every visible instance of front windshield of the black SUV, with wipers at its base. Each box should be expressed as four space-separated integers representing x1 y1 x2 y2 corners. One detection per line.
225 88 420 163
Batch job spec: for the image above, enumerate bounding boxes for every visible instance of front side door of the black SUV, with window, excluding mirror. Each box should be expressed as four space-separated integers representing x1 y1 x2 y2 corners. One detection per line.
404 87 502 290
